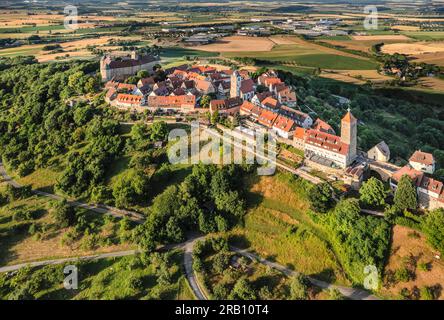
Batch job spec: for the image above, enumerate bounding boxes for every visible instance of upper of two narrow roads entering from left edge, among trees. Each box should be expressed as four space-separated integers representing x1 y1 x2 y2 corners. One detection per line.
0 162 145 223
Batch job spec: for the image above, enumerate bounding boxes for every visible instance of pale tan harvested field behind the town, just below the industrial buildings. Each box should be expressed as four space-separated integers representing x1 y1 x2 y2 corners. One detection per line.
193 36 274 52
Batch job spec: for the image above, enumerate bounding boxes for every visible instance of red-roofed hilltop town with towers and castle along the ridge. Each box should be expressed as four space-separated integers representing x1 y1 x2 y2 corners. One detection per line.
101 52 444 209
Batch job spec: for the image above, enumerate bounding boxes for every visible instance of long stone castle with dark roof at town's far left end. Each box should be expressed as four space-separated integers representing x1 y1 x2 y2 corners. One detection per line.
100 51 159 81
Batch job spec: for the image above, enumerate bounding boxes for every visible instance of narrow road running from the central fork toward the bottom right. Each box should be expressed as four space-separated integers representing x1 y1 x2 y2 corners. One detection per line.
231 247 379 300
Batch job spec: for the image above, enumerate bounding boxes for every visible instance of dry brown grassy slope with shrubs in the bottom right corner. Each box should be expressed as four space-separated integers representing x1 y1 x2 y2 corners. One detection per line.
381 225 444 300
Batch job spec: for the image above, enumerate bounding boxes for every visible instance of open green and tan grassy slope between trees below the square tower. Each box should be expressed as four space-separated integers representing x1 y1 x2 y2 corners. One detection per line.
231 173 347 283
